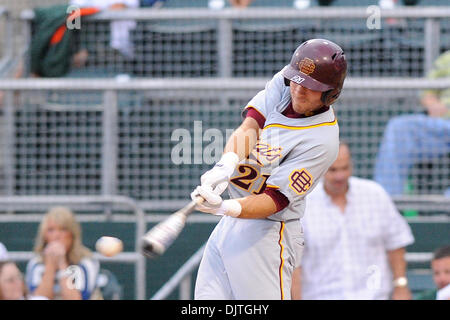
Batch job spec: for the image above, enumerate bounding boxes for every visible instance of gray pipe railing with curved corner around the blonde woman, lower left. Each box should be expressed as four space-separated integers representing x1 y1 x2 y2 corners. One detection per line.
0 195 146 300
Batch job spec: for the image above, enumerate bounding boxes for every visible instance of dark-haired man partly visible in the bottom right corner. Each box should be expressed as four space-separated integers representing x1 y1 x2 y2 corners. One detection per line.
417 245 450 300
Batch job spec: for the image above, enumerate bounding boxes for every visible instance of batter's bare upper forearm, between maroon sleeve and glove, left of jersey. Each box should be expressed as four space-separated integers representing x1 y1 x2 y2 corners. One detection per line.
223 118 259 160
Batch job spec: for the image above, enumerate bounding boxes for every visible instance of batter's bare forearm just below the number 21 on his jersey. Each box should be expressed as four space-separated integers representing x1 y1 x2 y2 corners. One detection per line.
236 193 277 219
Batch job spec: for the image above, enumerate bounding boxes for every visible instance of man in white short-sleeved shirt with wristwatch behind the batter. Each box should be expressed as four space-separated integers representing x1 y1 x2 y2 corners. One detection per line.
292 142 414 300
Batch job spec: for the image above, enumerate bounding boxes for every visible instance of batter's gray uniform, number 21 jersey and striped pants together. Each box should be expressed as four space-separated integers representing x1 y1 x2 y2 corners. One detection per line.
195 73 339 299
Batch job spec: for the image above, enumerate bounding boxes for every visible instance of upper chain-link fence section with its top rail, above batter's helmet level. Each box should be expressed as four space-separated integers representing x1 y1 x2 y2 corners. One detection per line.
7 7 450 78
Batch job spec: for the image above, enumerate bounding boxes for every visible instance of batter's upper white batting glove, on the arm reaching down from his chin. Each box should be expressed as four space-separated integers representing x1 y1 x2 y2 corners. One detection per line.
200 152 239 195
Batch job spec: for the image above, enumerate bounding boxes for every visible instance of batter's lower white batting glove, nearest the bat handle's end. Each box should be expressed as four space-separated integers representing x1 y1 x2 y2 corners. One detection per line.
191 186 242 218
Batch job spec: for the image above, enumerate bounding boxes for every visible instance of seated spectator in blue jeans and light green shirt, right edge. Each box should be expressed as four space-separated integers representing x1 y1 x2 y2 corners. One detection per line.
374 50 450 195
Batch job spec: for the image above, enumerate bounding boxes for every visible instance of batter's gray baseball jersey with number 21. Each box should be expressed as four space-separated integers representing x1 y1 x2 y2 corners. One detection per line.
228 73 339 221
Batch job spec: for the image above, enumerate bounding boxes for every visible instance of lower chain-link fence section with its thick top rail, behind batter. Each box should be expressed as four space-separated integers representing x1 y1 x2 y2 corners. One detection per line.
0 78 450 211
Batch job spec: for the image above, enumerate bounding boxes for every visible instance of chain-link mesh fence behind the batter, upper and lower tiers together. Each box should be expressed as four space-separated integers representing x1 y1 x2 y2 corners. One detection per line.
1 7 450 203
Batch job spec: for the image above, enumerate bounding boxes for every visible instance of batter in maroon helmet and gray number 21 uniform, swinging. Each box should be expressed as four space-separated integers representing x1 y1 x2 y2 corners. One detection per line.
191 39 347 300
